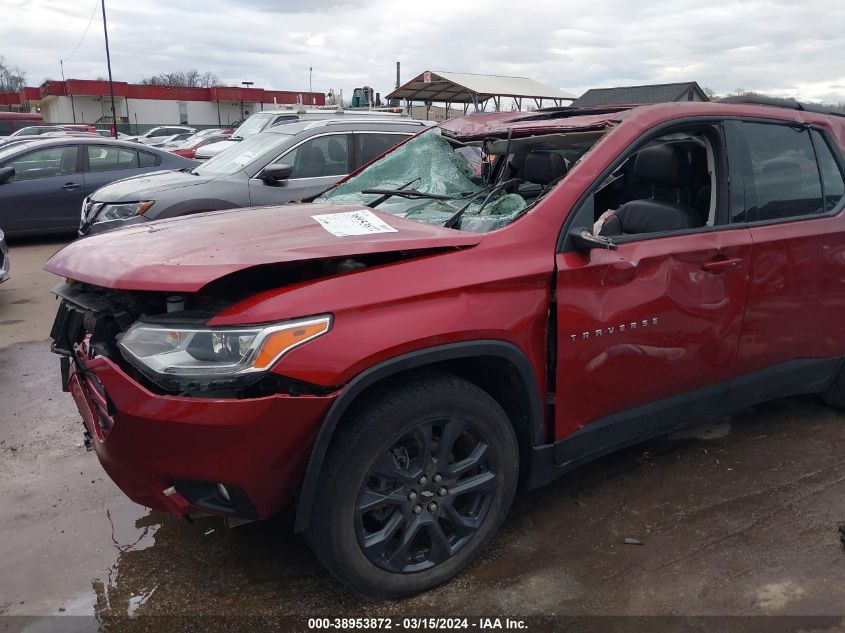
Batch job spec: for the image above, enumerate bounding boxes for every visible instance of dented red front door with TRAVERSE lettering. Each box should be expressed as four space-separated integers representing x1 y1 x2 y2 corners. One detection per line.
555 128 752 463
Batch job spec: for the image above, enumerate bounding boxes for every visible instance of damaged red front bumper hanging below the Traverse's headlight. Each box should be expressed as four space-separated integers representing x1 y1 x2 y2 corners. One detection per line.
63 343 335 519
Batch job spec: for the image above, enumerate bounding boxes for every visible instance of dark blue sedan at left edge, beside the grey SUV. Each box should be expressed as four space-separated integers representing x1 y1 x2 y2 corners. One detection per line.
0 135 196 237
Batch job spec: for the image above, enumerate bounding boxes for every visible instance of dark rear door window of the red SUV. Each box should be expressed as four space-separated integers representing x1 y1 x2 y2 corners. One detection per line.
742 123 824 222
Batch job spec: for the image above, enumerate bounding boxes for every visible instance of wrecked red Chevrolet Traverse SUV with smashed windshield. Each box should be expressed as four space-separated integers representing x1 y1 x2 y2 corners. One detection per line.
46 103 845 598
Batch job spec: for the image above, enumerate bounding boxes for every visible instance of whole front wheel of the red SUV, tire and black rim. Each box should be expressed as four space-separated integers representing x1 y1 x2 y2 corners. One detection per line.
307 375 519 599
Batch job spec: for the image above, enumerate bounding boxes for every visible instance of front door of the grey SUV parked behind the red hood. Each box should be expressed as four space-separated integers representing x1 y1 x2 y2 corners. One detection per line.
249 132 351 206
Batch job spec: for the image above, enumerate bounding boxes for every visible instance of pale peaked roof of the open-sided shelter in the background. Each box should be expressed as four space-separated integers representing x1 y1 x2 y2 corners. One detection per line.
387 70 576 103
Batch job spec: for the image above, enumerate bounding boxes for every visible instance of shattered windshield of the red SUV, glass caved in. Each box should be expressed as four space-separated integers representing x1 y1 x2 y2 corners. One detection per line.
314 128 603 233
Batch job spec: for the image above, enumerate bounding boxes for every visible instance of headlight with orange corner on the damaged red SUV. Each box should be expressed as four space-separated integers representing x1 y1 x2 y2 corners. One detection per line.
118 315 332 380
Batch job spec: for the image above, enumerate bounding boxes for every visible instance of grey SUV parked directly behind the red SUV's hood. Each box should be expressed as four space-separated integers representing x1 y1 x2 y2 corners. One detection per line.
79 119 426 235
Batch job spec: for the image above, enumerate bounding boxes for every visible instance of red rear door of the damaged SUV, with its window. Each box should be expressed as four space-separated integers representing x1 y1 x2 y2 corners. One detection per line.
727 121 845 403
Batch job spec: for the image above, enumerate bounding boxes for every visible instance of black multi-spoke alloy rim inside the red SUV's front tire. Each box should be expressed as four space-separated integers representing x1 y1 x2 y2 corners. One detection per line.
355 418 497 573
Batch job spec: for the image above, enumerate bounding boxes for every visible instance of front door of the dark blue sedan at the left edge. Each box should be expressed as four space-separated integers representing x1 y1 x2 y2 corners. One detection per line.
0 145 85 233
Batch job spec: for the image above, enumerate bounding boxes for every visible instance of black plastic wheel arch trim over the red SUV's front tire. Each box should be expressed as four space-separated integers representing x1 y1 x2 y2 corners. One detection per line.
294 340 545 532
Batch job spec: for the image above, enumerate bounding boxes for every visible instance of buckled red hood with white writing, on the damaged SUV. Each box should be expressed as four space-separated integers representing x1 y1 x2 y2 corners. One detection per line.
44 204 482 292
